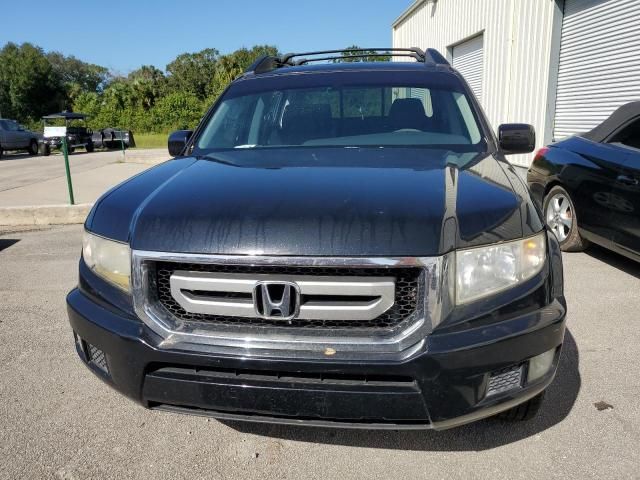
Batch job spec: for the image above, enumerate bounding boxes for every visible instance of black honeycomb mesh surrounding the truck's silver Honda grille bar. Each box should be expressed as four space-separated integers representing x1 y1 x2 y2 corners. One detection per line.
152 262 422 331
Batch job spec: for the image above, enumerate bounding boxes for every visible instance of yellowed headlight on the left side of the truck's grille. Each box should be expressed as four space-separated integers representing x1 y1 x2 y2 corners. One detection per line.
82 232 131 291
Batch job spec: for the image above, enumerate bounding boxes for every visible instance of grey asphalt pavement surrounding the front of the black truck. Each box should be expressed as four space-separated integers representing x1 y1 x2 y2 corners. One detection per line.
0 226 640 480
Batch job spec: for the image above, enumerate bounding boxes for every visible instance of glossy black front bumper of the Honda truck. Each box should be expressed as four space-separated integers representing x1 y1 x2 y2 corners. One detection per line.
67 289 566 429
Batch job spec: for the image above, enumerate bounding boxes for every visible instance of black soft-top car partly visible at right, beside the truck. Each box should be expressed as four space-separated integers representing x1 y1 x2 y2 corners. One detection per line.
527 102 640 261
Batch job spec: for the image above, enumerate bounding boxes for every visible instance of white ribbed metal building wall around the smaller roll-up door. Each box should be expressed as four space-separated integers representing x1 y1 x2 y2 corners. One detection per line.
393 0 560 166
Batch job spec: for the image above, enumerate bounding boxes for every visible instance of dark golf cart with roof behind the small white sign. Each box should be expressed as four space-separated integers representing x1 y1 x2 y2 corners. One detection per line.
40 112 93 155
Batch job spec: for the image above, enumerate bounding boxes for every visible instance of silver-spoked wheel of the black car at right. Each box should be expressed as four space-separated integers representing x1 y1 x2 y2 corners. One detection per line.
543 185 589 252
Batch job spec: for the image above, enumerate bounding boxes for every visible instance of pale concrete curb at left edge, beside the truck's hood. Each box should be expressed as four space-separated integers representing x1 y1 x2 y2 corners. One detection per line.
0 203 93 227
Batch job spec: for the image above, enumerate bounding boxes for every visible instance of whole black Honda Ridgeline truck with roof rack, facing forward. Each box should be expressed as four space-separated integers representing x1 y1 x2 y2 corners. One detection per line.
67 48 566 429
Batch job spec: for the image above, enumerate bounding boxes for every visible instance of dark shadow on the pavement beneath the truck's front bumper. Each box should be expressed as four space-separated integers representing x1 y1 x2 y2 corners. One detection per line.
222 329 581 451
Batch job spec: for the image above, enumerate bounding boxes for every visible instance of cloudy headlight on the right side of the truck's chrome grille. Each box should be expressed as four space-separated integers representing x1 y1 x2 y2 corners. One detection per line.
456 232 547 305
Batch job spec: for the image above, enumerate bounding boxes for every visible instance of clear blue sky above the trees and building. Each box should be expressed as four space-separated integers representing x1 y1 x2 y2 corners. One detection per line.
0 0 420 74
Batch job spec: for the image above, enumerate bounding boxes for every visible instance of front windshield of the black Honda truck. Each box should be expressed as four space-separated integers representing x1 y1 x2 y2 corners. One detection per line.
196 75 484 151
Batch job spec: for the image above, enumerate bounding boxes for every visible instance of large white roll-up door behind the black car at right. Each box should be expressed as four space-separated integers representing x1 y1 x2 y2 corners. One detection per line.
554 0 640 140
